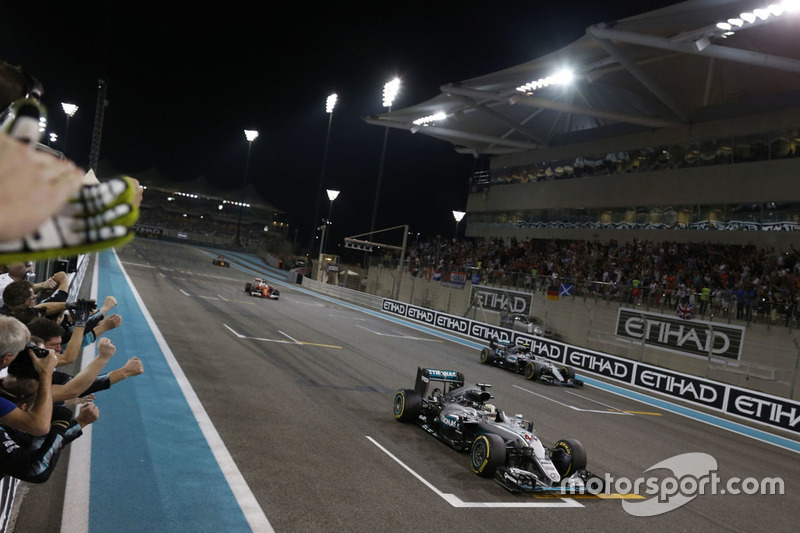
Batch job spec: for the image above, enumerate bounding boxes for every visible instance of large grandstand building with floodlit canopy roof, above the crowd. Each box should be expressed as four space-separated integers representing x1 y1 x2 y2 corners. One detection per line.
365 0 800 249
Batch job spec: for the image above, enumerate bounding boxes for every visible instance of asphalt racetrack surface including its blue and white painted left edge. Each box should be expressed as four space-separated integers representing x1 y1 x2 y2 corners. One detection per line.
12 239 800 533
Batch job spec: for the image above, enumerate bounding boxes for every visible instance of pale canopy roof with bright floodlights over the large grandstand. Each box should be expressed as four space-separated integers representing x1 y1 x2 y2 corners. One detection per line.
365 0 800 156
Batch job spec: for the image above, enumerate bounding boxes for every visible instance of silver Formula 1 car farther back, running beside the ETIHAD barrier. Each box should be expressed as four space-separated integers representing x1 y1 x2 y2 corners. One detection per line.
480 338 583 387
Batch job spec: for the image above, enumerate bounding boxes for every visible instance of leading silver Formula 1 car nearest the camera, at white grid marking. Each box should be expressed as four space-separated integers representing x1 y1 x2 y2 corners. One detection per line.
394 368 602 493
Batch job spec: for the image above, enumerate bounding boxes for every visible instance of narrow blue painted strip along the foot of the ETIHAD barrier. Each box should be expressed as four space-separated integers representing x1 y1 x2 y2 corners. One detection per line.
211 248 800 453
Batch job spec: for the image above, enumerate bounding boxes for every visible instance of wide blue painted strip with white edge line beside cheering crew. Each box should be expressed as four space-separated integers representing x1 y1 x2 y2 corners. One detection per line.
75 251 273 533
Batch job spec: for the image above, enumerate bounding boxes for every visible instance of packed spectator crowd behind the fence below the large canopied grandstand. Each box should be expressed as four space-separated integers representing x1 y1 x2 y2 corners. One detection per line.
408 239 800 325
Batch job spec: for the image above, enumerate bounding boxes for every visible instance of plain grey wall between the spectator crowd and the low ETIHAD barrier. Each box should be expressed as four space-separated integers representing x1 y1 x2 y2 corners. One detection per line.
366 267 800 400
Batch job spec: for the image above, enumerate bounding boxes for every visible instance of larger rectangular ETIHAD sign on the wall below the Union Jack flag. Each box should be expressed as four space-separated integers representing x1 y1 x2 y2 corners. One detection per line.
616 308 744 359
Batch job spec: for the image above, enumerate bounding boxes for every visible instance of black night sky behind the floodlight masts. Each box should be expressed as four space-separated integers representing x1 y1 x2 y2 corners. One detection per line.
0 0 675 249
